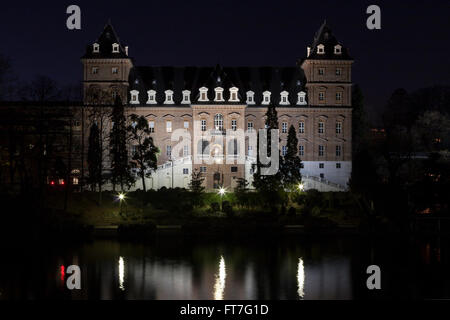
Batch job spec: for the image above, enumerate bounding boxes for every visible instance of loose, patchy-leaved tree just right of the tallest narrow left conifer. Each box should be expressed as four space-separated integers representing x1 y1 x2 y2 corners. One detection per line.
127 114 159 191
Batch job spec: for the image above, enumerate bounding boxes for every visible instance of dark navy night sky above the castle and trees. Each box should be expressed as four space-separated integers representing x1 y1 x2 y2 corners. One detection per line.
0 0 450 124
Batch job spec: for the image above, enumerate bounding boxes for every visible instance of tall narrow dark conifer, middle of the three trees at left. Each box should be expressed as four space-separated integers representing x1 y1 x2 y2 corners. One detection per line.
109 97 134 191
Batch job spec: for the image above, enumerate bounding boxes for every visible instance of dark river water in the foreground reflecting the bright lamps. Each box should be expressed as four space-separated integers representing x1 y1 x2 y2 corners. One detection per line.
0 236 450 300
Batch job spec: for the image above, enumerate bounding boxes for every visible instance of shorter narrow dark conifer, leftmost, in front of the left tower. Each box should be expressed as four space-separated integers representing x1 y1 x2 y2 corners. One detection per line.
87 122 102 191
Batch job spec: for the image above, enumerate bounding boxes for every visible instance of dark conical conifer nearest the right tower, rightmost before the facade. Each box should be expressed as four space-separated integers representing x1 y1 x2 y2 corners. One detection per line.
281 125 302 191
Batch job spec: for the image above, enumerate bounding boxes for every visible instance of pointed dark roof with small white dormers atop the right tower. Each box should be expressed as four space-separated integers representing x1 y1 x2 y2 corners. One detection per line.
306 20 352 60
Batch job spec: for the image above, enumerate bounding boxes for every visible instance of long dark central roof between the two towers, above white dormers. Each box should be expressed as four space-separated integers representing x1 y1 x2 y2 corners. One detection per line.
129 65 306 105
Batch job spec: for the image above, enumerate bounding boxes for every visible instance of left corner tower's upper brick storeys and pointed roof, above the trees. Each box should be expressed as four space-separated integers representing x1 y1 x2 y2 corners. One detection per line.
81 23 133 103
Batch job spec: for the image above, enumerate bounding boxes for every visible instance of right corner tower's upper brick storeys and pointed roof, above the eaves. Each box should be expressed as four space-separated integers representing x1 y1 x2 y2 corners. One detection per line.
301 21 353 107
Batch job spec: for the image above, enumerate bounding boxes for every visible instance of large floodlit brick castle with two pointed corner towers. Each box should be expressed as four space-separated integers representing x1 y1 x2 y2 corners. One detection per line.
81 23 353 191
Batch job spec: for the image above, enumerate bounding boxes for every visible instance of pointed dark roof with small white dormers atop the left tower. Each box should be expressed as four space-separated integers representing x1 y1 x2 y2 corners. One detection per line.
82 23 129 59
